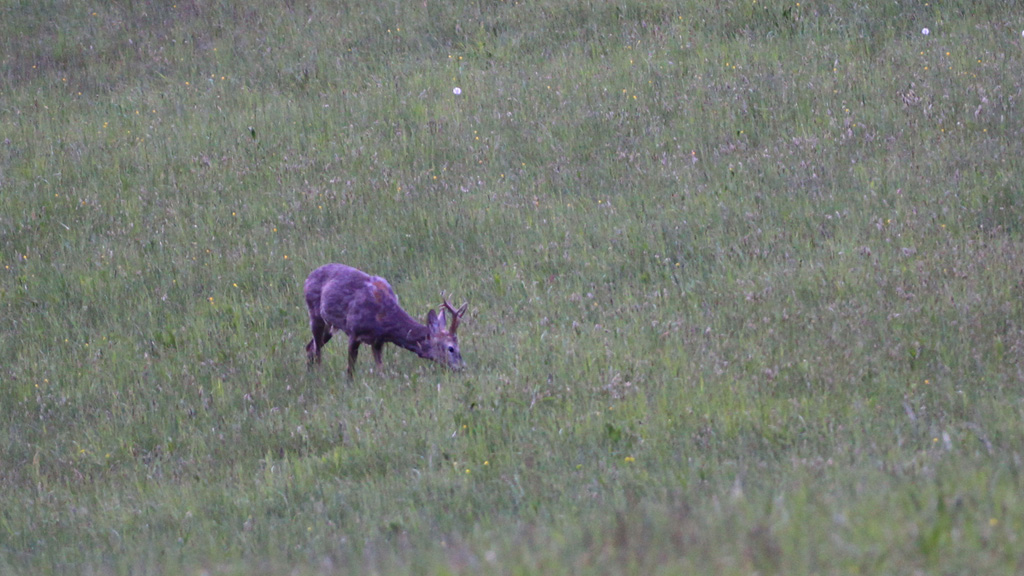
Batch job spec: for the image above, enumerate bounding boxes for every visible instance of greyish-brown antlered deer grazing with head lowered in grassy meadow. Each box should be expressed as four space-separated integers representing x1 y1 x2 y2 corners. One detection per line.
305 264 469 377
